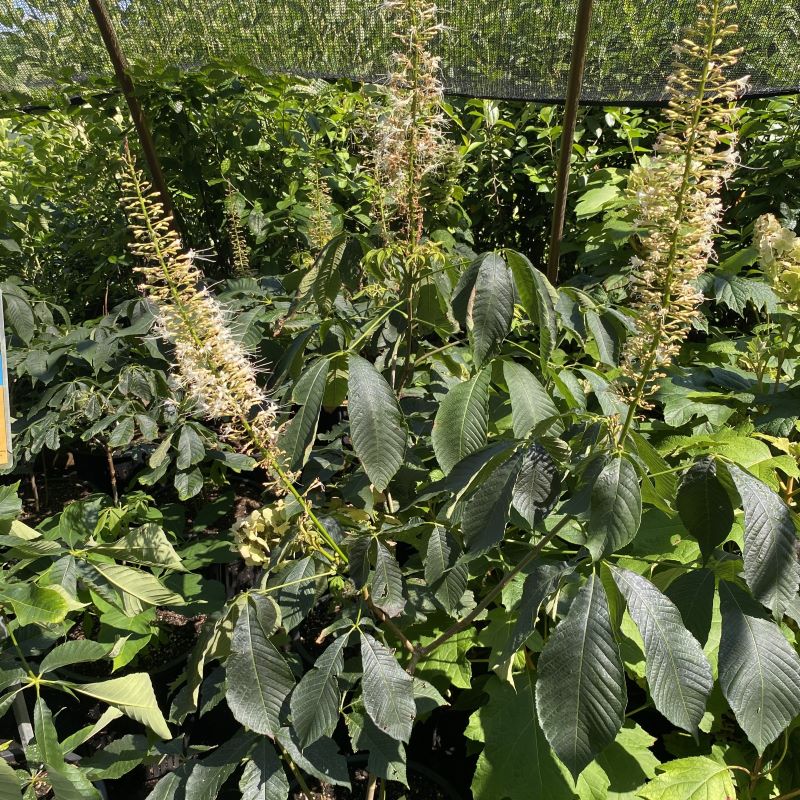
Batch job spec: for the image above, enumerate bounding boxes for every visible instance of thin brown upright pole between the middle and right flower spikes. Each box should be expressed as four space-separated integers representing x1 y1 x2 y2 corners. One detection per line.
547 0 592 284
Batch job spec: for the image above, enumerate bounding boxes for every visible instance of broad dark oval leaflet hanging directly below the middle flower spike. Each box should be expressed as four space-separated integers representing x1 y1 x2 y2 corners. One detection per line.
347 355 408 492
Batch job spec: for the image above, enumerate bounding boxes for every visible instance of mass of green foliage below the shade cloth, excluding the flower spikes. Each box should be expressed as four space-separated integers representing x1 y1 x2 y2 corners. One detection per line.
0 40 800 800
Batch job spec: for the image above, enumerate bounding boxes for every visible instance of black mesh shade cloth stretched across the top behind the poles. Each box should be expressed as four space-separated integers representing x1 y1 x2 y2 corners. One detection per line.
0 0 800 105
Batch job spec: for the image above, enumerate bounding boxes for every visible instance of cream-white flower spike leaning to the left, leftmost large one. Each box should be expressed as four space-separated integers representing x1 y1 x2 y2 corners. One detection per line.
121 147 277 462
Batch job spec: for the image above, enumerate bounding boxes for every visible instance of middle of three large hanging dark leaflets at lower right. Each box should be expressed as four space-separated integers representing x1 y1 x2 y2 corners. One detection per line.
611 567 714 734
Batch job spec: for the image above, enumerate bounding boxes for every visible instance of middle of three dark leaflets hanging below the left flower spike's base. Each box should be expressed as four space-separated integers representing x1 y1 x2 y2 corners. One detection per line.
290 634 348 747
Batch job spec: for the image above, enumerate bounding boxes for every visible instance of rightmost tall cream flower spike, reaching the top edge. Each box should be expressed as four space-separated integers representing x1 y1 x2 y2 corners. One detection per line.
620 0 746 413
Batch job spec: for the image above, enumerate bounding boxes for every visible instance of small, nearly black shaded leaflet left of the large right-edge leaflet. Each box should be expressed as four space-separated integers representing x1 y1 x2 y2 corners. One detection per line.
675 458 733 560
